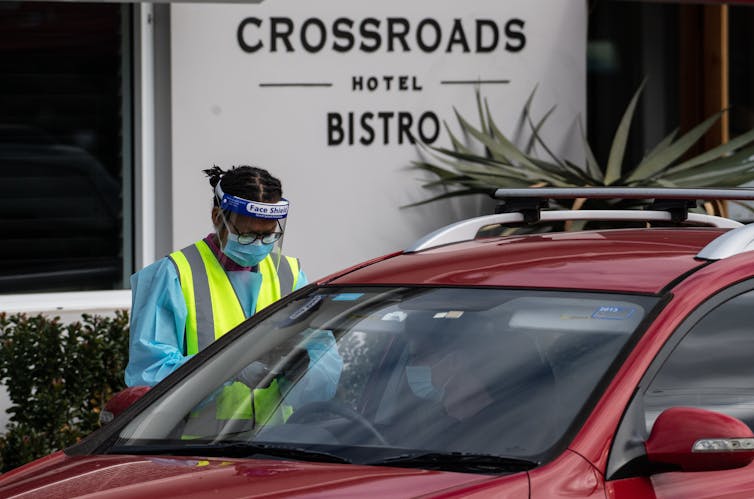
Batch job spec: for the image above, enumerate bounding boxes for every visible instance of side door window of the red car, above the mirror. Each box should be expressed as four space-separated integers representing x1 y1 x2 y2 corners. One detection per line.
644 291 754 432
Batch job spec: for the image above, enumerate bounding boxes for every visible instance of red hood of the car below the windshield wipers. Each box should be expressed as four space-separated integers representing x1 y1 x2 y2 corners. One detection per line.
0 452 508 499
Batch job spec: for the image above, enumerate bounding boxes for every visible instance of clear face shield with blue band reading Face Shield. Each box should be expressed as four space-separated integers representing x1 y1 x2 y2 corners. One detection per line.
215 182 289 271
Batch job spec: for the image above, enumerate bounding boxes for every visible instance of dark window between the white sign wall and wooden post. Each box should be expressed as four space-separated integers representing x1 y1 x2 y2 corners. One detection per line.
587 0 681 170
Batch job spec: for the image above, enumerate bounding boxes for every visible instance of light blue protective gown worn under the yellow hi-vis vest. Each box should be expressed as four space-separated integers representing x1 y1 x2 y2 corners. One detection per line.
125 248 343 406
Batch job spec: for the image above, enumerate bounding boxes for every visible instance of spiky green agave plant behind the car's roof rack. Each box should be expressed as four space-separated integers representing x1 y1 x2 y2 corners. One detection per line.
408 82 754 221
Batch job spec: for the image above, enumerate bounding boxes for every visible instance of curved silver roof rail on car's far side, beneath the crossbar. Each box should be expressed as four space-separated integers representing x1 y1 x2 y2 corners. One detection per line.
404 211 740 253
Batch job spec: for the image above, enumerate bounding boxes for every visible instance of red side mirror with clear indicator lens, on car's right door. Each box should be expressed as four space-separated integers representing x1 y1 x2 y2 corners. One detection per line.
645 407 754 471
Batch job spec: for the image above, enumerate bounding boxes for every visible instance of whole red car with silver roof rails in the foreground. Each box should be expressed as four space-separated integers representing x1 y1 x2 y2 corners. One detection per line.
0 189 754 499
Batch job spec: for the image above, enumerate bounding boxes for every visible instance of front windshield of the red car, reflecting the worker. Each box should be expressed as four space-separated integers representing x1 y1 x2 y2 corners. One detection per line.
110 286 657 471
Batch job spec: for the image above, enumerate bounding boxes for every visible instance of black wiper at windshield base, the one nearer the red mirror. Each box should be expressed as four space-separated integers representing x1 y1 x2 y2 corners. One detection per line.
367 452 539 473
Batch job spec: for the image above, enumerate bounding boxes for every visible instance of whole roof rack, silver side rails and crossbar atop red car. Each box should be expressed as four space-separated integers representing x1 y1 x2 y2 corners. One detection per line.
405 187 754 260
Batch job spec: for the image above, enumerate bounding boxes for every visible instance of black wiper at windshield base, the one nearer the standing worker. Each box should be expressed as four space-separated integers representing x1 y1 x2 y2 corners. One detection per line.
111 442 351 464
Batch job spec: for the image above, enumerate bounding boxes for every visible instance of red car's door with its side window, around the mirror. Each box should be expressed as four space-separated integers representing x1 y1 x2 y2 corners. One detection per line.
606 282 754 499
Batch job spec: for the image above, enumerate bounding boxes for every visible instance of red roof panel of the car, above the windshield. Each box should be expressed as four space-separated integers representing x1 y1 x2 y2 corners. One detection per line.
330 227 729 294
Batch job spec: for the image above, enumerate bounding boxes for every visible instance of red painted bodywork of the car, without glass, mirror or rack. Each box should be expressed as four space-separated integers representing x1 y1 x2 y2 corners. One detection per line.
0 229 754 499
